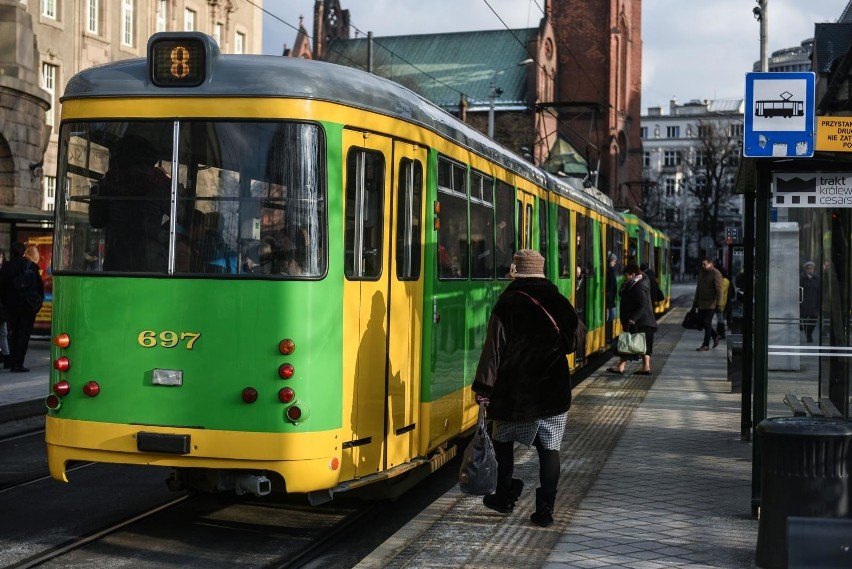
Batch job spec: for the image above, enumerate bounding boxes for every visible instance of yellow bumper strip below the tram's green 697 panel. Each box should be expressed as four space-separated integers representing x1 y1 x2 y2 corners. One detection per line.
45 416 342 492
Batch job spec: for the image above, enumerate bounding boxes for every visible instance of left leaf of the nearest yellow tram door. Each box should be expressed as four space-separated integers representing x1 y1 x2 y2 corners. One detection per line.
341 130 398 478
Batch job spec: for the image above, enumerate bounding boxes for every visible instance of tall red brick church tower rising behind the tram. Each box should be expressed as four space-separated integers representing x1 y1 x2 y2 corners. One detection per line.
551 0 643 210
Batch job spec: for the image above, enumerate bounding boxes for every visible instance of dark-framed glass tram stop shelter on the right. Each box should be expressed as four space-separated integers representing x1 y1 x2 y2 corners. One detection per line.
732 33 852 513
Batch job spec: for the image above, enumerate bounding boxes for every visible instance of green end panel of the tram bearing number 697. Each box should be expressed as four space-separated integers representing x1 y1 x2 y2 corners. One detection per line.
51 275 343 432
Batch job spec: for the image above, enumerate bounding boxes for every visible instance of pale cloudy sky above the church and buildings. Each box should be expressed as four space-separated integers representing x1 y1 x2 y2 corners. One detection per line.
263 0 847 113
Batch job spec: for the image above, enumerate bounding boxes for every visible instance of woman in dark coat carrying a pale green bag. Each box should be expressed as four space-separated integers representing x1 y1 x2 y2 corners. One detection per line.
607 261 657 375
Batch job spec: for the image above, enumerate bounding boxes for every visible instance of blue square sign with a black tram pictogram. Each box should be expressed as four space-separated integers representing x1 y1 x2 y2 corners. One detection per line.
743 71 816 158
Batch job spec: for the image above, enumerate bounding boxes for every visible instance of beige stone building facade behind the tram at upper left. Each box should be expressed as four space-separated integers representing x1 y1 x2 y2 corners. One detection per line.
0 0 263 241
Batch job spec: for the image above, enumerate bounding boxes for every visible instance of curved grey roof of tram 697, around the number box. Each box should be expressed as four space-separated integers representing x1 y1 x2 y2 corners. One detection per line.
60 50 545 185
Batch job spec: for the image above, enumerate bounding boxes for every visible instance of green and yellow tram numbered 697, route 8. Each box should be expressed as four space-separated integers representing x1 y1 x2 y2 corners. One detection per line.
46 32 668 503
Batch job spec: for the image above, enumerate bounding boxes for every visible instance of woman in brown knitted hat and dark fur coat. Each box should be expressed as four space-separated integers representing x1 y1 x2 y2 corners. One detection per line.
472 249 580 527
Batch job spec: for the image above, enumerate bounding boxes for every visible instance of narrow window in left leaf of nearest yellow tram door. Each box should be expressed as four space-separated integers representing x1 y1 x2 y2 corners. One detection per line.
344 148 385 279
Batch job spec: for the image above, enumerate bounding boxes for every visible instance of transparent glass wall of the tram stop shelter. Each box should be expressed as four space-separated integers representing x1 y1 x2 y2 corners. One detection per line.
768 195 852 417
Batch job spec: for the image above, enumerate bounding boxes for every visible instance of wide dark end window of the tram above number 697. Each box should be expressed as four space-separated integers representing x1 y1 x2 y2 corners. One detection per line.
53 121 327 278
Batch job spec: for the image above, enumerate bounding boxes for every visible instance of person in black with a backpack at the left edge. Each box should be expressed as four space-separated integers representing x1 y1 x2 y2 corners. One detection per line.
0 241 44 373
